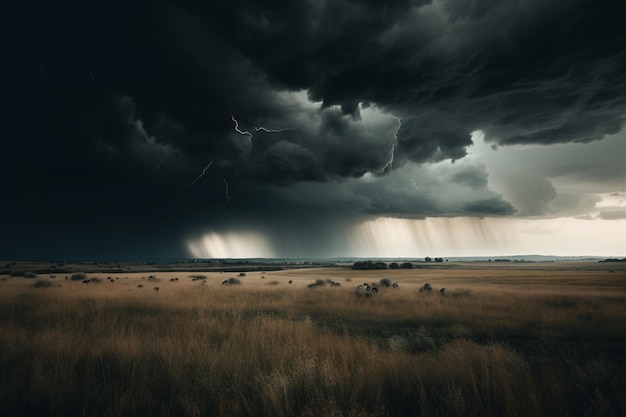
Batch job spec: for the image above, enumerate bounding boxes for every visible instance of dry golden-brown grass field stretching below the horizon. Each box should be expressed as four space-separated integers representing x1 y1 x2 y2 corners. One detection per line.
0 262 626 417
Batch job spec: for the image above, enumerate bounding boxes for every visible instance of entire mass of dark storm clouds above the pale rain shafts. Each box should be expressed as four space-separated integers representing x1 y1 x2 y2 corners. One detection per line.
0 0 626 258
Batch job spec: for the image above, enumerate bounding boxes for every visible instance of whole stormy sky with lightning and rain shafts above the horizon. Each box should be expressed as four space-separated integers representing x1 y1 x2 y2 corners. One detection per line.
0 0 626 260
